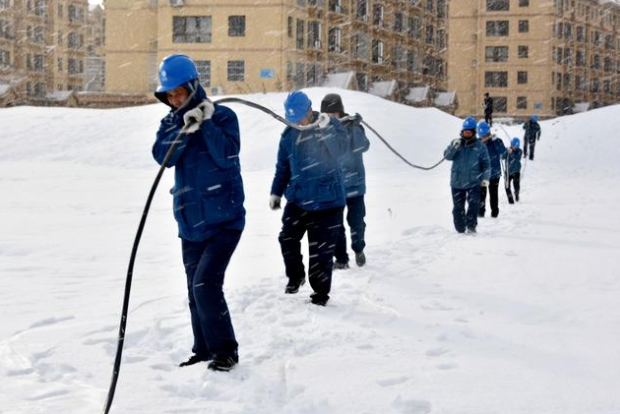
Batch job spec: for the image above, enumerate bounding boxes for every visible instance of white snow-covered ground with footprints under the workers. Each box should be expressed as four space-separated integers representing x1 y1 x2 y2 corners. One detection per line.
0 89 620 414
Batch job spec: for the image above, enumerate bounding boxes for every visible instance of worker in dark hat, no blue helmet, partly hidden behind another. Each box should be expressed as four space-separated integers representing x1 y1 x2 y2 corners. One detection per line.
321 93 370 269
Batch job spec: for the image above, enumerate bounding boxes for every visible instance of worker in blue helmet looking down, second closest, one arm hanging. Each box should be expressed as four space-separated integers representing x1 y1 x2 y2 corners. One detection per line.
269 91 348 306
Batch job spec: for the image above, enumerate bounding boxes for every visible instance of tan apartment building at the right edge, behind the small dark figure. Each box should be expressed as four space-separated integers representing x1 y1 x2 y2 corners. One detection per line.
448 0 620 119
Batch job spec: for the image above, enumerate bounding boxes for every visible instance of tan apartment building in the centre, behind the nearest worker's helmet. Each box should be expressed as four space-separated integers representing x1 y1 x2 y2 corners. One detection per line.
105 0 448 102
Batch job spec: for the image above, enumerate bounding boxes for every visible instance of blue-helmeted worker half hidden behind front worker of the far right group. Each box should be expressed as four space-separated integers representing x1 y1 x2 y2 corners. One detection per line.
477 121 506 218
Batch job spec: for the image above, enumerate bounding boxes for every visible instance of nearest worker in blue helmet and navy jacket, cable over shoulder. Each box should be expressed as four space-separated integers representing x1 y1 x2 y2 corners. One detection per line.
153 55 245 371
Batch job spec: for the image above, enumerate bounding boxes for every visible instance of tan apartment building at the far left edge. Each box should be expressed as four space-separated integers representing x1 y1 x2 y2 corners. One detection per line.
0 0 88 102
